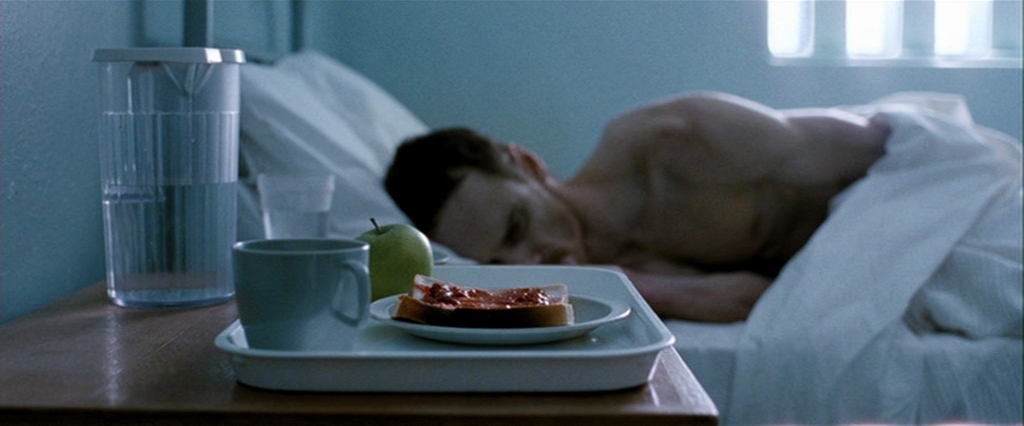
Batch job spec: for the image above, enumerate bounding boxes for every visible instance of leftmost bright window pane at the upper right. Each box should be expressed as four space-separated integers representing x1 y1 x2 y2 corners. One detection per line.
768 0 814 57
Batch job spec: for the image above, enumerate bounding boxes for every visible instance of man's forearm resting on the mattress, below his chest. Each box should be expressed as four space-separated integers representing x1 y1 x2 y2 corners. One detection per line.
626 270 771 323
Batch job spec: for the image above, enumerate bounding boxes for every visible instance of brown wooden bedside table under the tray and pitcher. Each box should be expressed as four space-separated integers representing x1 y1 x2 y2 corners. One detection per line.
0 283 718 426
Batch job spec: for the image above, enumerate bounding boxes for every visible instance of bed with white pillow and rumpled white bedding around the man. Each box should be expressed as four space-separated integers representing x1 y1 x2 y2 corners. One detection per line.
201 2 1024 424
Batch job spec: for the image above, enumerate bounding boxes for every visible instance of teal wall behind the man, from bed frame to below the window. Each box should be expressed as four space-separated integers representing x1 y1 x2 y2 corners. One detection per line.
307 0 1022 177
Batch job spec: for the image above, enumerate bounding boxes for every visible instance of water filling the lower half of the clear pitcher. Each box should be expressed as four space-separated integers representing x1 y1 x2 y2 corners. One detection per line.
103 182 237 307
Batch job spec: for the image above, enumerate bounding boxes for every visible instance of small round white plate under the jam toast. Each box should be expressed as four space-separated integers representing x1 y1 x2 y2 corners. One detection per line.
370 296 630 345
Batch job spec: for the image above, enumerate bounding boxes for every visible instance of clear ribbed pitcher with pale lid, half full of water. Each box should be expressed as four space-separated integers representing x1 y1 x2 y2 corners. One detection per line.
93 47 245 307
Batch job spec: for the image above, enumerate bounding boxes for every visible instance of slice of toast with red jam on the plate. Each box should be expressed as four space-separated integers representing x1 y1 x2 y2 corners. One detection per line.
391 275 573 329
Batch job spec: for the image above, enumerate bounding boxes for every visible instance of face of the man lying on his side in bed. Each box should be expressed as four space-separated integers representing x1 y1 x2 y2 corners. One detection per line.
431 171 587 264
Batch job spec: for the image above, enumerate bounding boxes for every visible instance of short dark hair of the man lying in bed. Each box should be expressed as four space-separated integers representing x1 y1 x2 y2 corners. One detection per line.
384 127 517 235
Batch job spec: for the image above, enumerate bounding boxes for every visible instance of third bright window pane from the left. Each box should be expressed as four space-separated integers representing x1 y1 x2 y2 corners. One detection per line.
935 0 992 57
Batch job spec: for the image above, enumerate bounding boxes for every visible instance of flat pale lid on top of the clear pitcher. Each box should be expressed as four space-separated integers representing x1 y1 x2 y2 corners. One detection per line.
92 47 246 63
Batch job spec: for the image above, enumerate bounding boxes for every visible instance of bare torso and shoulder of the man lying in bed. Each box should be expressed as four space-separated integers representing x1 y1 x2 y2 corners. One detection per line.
565 94 888 275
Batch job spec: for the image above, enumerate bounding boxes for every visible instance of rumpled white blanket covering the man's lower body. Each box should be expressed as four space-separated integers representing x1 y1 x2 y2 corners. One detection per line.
670 95 1024 424
